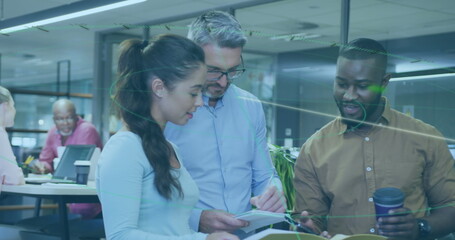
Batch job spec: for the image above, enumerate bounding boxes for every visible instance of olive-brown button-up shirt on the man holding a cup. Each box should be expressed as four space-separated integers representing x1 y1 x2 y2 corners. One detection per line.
294 99 455 235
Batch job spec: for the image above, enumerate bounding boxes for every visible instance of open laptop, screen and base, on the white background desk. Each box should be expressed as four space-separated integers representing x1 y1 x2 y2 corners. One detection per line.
25 145 99 184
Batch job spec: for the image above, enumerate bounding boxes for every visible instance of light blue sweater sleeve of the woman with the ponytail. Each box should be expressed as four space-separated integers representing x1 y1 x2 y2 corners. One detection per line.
97 135 207 240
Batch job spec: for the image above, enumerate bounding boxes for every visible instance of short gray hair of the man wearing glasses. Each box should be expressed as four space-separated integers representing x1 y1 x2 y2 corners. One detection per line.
188 11 247 48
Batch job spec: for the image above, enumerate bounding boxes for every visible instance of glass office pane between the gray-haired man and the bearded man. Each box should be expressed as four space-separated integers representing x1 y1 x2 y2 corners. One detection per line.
242 0 340 147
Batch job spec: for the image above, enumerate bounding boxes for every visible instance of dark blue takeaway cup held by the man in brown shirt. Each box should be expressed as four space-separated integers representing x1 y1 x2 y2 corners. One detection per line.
373 187 404 220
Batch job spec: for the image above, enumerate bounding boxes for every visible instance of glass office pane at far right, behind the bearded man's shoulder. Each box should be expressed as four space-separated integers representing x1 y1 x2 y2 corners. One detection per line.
349 0 455 141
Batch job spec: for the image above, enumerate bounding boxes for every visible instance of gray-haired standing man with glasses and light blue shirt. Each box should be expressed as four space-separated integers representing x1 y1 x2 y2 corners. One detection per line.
165 11 286 237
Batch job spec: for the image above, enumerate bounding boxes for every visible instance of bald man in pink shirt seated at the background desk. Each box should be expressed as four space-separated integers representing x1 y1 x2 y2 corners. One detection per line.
31 99 103 219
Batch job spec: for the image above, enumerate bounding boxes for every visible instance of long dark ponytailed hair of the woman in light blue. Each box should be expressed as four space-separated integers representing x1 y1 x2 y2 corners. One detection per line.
114 35 205 199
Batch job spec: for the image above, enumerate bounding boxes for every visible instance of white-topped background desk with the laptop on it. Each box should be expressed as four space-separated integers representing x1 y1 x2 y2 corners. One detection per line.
1 184 99 240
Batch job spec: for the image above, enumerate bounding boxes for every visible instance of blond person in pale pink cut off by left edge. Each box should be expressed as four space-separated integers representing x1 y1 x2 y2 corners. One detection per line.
0 86 24 185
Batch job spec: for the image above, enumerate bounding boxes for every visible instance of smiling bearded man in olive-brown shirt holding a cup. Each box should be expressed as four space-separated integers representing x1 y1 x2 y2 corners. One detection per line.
294 39 455 240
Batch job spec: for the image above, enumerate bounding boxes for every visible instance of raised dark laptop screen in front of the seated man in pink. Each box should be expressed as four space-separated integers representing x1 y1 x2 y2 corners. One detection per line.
53 145 96 181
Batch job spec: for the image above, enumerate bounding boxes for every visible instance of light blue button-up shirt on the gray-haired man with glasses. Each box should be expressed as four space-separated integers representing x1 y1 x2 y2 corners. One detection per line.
164 85 281 231
